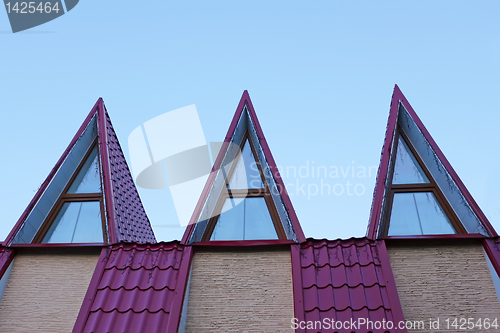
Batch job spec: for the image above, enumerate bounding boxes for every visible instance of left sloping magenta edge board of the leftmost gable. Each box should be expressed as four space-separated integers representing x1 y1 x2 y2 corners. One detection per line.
3 98 102 245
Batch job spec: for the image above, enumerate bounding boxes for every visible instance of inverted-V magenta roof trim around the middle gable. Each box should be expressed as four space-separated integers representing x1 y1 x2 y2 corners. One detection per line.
181 90 305 244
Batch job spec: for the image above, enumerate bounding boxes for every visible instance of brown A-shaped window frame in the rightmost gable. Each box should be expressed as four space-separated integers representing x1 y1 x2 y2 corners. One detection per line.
379 125 468 237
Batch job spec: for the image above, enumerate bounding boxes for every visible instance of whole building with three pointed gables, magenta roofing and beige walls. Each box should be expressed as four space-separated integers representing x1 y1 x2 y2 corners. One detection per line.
0 86 500 333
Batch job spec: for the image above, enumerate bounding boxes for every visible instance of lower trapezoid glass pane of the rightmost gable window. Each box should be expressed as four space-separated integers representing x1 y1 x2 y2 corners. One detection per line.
388 192 456 236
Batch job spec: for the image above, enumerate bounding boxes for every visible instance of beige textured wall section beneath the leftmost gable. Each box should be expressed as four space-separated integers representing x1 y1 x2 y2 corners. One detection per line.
0 254 99 333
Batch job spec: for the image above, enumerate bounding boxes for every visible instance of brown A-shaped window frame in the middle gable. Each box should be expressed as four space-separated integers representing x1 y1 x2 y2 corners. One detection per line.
201 132 287 242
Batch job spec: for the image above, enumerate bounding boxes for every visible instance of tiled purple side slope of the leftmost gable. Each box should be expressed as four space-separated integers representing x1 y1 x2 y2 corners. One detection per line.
102 111 156 243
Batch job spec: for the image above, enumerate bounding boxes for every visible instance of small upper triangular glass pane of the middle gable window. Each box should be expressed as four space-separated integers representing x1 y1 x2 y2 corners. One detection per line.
228 140 264 189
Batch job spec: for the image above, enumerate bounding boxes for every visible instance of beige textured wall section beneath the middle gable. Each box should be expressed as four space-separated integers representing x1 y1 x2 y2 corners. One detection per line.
186 250 294 333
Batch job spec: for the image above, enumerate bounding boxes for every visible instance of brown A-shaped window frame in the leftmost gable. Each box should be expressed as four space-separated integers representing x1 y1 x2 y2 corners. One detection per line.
31 138 107 244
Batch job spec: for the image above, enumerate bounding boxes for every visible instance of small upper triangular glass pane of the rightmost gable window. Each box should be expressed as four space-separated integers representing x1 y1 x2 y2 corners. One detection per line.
392 136 429 184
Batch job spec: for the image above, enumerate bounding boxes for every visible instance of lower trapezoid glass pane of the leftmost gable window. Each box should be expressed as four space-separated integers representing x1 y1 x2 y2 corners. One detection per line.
42 201 103 243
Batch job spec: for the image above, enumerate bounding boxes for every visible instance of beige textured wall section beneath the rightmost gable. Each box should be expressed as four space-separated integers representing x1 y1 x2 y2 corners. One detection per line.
388 244 500 332
